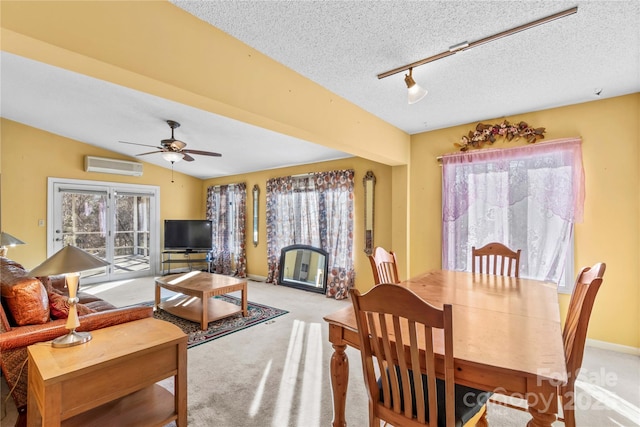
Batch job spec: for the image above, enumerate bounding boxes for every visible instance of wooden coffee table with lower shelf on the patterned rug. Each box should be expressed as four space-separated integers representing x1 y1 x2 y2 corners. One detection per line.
155 271 249 331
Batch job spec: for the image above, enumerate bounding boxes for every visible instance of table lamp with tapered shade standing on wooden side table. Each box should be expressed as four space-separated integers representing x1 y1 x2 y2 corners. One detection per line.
29 245 109 347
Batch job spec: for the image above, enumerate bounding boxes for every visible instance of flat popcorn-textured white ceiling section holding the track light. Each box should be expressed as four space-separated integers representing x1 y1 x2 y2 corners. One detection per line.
173 1 640 134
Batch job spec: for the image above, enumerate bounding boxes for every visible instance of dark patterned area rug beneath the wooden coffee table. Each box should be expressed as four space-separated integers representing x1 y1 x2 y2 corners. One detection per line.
150 295 288 348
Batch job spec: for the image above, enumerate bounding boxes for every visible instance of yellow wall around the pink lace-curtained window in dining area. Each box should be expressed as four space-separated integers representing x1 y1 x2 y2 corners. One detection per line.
409 93 640 348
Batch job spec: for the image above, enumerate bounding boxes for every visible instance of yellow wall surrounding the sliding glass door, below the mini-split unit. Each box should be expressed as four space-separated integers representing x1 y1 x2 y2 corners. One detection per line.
0 119 204 268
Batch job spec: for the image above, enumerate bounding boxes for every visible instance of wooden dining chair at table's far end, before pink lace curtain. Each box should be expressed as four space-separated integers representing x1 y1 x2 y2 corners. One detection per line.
471 242 521 277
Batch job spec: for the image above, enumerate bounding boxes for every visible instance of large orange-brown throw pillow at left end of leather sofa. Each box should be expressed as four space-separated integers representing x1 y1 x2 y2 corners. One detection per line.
2 277 49 326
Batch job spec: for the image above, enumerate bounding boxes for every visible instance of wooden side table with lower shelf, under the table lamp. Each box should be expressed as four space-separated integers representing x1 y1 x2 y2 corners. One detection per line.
27 318 187 427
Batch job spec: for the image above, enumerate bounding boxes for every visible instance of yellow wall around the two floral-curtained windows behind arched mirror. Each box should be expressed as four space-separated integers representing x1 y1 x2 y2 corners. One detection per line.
202 157 393 289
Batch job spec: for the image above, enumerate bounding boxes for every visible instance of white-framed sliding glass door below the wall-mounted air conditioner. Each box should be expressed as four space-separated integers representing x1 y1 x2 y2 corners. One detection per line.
47 178 160 283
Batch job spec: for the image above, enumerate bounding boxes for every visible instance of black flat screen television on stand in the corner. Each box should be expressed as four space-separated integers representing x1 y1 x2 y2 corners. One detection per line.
164 219 213 252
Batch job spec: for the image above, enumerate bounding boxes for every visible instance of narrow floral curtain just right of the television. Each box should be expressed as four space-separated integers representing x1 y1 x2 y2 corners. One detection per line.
207 183 247 277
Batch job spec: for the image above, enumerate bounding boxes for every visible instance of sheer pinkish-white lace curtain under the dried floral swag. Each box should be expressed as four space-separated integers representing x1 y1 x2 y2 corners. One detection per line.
442 139 584 283
